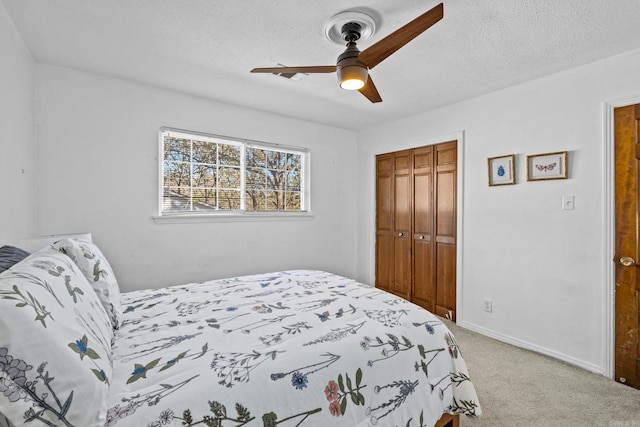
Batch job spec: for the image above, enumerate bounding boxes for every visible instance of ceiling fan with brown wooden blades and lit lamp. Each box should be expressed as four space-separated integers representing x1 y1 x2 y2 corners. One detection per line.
251 3 444 102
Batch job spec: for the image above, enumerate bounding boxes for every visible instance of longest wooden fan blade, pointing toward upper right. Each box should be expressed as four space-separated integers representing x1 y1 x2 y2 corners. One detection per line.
358 3 444 69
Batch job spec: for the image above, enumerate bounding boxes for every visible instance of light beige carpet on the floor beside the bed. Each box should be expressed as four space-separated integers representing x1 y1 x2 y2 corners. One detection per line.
445 320 640 427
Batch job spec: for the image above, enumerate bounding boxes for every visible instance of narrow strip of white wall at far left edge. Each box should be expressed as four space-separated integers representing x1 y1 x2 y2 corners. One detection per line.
0 2 36 246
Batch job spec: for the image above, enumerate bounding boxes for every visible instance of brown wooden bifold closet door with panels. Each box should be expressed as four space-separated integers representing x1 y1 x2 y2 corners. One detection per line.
376 141 457 320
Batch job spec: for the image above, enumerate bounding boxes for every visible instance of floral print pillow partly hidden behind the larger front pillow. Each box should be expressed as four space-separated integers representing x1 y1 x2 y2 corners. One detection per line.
53 239 122 329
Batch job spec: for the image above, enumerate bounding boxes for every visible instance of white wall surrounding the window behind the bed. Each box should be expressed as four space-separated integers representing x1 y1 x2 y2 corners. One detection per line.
36 64 356 290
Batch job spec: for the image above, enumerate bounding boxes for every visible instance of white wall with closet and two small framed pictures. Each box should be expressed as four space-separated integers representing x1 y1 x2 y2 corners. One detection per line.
358 47 640 373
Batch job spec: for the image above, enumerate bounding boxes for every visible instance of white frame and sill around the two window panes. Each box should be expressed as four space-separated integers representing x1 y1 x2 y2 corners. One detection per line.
158 127 312 223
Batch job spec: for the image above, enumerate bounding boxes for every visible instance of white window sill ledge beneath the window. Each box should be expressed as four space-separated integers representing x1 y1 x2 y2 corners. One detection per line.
152 212 314 224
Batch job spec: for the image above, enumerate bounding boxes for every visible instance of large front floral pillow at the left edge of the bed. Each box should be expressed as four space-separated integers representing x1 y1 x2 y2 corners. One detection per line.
0 247 113 427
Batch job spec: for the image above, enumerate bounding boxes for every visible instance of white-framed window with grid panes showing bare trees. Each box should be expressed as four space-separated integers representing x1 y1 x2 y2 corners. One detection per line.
160 129 309 215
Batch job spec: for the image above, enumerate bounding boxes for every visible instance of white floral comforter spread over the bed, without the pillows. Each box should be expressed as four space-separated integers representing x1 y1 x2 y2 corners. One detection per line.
106 270 481 427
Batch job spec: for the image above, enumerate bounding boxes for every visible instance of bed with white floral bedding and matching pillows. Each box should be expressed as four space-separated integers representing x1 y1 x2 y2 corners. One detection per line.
0 239 481 427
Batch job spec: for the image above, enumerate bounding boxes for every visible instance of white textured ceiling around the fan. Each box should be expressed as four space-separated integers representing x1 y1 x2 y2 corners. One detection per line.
1 0 640 130
